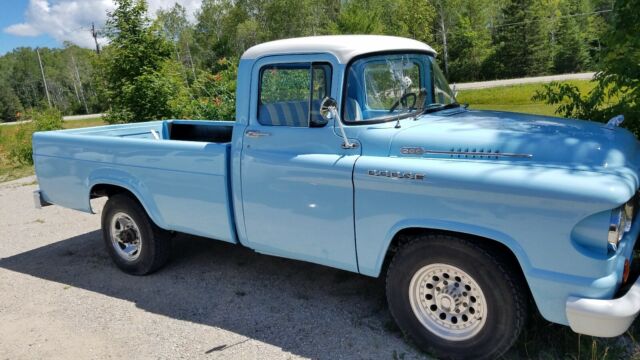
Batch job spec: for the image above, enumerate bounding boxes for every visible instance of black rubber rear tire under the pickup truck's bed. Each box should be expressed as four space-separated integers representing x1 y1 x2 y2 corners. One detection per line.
102 194 171 275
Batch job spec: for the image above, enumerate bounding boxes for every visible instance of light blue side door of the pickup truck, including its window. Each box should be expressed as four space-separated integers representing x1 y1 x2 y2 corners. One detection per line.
241 55 359 271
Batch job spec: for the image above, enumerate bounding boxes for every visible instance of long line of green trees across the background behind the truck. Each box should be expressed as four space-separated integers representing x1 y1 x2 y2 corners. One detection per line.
0 0 614 122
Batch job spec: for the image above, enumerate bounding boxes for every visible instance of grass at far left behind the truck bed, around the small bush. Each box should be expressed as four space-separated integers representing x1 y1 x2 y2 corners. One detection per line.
0 119 105 182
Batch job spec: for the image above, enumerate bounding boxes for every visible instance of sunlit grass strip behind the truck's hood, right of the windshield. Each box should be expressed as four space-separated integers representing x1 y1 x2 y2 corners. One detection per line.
458 80 593 116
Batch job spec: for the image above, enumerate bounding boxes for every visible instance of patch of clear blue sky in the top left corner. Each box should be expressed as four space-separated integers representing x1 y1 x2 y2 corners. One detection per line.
0 0 62 54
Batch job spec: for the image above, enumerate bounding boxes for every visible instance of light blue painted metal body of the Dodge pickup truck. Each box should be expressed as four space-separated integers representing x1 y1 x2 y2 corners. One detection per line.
34 47 640 330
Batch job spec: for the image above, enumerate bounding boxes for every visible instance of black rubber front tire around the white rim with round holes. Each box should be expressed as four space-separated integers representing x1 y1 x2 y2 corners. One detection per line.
386 235 528 359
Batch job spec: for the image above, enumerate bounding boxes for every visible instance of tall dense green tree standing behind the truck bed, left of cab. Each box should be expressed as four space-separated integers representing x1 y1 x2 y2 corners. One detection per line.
101 0 180 123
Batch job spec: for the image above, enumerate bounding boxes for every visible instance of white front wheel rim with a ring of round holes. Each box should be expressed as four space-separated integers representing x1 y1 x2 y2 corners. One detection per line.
409 264 487 341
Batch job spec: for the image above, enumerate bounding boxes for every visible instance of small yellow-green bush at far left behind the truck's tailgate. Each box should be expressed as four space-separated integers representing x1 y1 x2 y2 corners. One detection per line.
9 108 63 165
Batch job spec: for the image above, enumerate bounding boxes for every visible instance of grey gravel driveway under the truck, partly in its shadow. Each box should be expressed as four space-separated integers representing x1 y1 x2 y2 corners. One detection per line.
0 177 430 359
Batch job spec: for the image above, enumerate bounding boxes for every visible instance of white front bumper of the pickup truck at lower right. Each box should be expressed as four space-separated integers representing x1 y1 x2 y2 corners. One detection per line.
566 277 640 337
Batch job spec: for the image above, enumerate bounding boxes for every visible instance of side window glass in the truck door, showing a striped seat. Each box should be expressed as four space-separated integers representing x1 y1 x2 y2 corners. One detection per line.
258 63 331 127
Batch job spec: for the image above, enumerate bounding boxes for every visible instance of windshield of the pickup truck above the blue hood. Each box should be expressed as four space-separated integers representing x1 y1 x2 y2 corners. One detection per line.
343 54 457 124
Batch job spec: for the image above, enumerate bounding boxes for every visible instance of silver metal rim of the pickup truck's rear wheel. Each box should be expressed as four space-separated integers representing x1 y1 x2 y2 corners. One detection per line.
111 213 142 261
